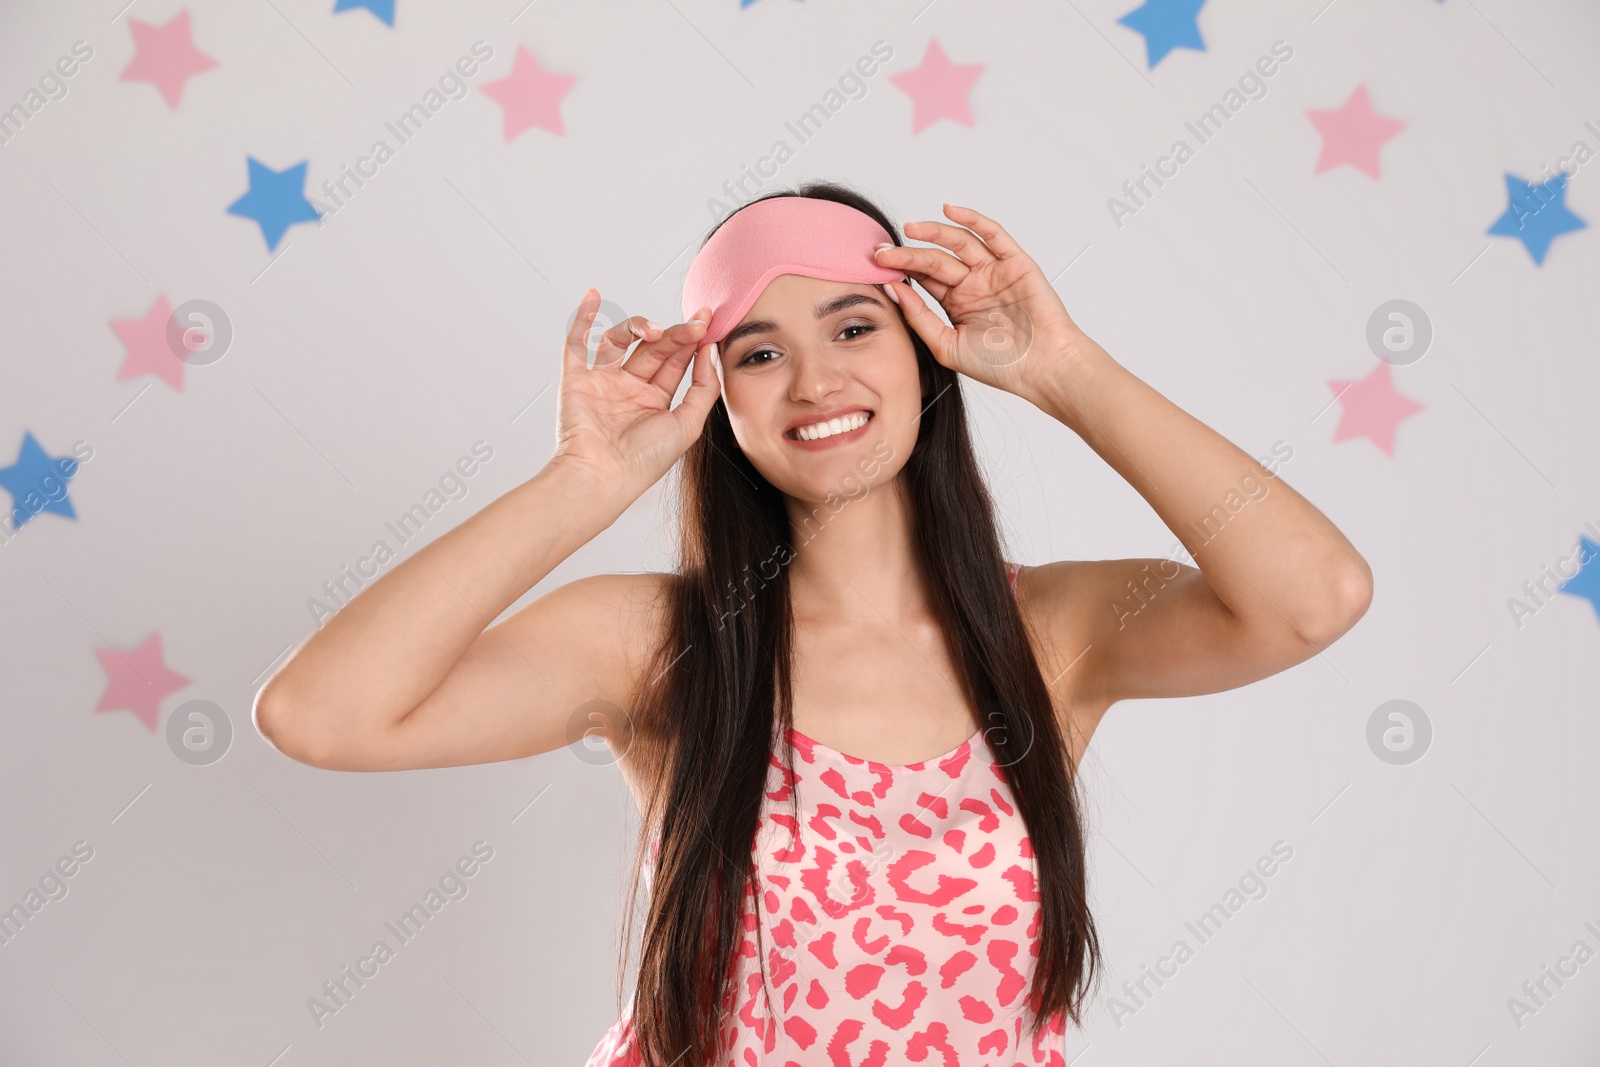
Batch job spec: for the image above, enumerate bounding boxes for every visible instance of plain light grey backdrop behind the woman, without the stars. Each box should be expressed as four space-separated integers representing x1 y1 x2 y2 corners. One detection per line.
0 0 1600 1067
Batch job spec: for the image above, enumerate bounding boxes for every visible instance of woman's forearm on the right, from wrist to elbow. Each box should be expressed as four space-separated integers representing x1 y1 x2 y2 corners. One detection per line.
1030 339 1371 632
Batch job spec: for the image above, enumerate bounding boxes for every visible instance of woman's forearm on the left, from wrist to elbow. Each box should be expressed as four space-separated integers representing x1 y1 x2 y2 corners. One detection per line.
256 461 637 736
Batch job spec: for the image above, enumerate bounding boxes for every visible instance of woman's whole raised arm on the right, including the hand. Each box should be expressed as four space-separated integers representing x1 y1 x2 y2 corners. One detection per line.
875 203 1373 744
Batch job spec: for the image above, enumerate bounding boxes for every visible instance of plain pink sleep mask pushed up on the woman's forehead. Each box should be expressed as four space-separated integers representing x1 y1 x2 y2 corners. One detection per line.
683 197 906 346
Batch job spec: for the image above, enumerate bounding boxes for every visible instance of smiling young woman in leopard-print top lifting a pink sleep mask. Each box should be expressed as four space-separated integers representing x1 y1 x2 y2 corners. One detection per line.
256 182 1371 1067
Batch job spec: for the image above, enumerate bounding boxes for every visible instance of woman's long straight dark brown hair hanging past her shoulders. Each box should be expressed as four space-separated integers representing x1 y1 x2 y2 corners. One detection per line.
618 182 1099 1067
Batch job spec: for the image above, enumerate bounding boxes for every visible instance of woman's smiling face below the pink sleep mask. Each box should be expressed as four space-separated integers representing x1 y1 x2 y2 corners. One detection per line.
717 274 923 502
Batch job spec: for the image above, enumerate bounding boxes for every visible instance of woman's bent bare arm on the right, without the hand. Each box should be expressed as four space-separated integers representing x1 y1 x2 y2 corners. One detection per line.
1019 338 1373 729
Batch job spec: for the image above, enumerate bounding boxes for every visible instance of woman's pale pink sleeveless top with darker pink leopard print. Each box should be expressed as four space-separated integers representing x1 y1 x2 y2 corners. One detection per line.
586 568 1066 1067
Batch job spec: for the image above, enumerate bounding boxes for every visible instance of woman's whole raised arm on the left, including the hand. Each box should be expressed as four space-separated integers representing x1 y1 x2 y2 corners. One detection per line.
254 290 718 771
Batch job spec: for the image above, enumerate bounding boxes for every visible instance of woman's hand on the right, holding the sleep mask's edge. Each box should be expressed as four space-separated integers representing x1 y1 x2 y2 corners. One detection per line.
877 203 1096 403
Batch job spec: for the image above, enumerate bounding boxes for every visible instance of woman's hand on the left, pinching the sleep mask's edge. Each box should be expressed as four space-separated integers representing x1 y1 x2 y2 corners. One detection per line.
550 286 720 498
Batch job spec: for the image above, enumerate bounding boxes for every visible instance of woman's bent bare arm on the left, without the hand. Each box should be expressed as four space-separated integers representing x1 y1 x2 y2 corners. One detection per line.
256 462 635 771
